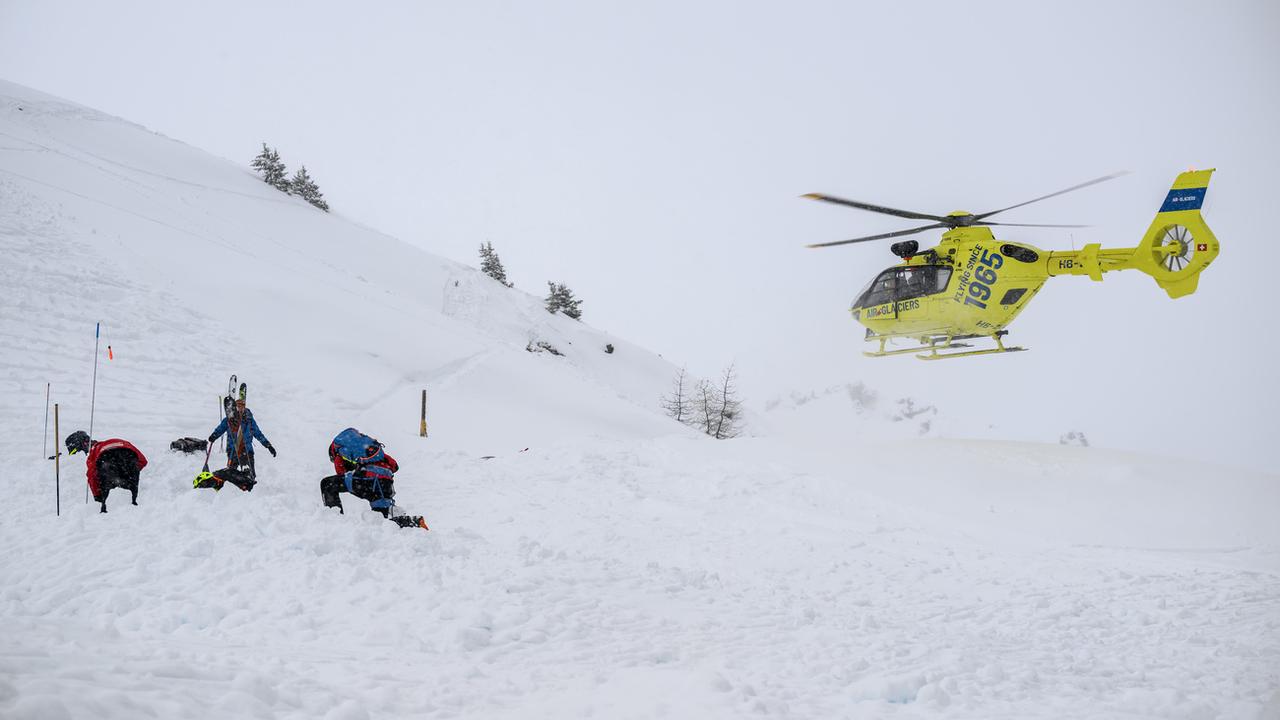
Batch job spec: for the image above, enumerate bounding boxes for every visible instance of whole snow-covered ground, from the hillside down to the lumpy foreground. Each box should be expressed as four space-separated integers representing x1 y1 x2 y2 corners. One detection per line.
0 78 1280 720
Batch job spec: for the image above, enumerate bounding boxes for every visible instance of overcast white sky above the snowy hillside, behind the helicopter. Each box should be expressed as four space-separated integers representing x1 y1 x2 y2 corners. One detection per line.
0 0 1280 468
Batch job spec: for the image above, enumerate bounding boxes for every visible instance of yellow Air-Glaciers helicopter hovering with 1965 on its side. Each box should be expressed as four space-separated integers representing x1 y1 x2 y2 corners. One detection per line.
804 169 1219 360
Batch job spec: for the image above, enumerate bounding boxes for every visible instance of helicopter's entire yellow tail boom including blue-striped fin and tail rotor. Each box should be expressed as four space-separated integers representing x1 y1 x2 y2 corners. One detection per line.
1047 169 1219 297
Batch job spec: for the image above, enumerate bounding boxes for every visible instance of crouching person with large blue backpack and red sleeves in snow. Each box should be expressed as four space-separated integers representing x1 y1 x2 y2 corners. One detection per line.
320 428 426 529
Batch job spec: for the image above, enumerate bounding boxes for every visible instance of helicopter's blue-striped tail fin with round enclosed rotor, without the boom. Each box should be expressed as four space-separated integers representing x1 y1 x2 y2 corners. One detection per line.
1133 169 1219 297
